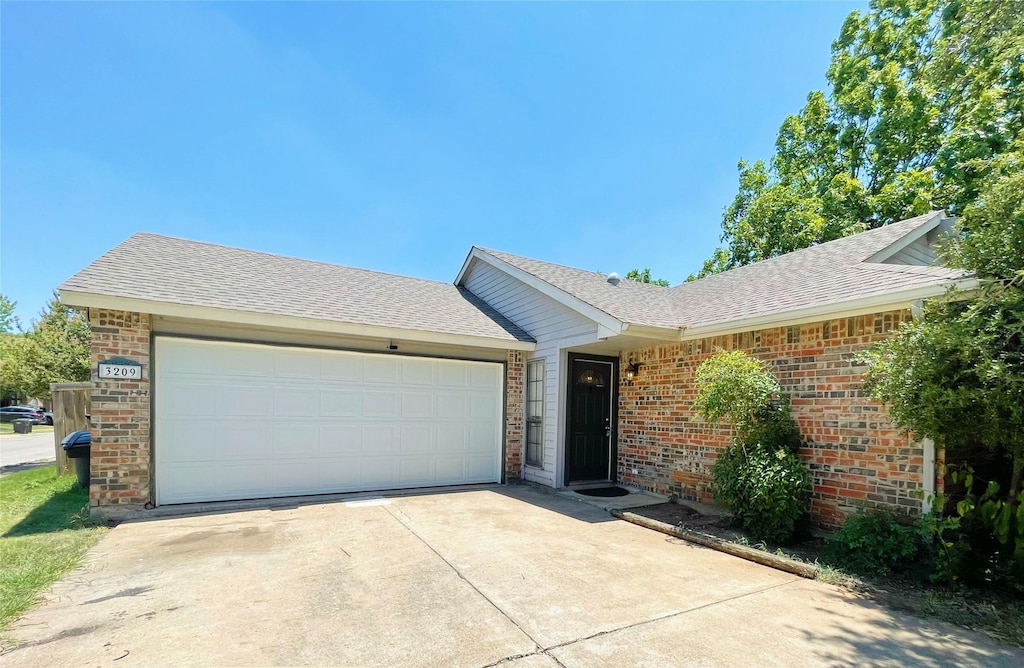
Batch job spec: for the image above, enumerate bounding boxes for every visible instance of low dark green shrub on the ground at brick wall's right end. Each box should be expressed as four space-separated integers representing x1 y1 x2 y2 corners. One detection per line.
824 510 931 576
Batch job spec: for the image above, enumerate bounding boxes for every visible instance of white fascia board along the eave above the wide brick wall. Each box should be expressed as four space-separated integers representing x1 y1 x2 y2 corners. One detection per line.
680 278 978 341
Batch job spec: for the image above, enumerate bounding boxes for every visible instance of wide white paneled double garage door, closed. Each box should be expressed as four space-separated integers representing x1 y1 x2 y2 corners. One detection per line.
154 337 504 504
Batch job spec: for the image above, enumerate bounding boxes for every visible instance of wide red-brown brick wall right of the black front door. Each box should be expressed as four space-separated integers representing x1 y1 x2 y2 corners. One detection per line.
618 310 926 528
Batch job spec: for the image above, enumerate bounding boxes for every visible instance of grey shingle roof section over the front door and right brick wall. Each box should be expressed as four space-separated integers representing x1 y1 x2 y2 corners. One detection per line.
471 212 965 328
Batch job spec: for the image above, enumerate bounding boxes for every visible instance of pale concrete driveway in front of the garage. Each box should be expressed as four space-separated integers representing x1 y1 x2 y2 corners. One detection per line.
0 487 1024 668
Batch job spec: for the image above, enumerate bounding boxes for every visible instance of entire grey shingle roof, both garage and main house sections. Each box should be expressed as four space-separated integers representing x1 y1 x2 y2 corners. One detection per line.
68 212 967 341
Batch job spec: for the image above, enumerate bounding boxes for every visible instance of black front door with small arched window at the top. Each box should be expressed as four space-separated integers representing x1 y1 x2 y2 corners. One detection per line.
565 356 615 483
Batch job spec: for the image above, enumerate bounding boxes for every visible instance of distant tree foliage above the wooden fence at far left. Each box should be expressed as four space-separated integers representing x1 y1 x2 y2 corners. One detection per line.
0 295 92 399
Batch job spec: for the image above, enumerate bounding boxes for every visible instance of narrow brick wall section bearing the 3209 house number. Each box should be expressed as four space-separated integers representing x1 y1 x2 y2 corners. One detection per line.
89 308 152 514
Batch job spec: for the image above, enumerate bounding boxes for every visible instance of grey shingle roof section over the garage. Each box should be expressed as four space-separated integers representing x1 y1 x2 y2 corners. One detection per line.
60 233 532 341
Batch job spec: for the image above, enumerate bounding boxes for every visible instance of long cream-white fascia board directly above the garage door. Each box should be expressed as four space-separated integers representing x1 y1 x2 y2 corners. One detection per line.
59 290 537 350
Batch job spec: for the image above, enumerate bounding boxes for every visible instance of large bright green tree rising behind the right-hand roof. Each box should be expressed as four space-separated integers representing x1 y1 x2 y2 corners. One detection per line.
691 0 1024 278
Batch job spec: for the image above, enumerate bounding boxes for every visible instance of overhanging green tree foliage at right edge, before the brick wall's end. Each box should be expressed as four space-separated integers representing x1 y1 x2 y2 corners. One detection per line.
865 140 1024 589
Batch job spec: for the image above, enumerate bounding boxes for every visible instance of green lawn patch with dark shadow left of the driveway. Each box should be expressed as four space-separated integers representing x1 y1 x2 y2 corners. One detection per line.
0 466 106 631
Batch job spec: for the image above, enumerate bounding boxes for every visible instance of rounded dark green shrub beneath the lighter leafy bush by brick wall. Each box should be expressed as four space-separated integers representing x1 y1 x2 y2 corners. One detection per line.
712 443 811 544
